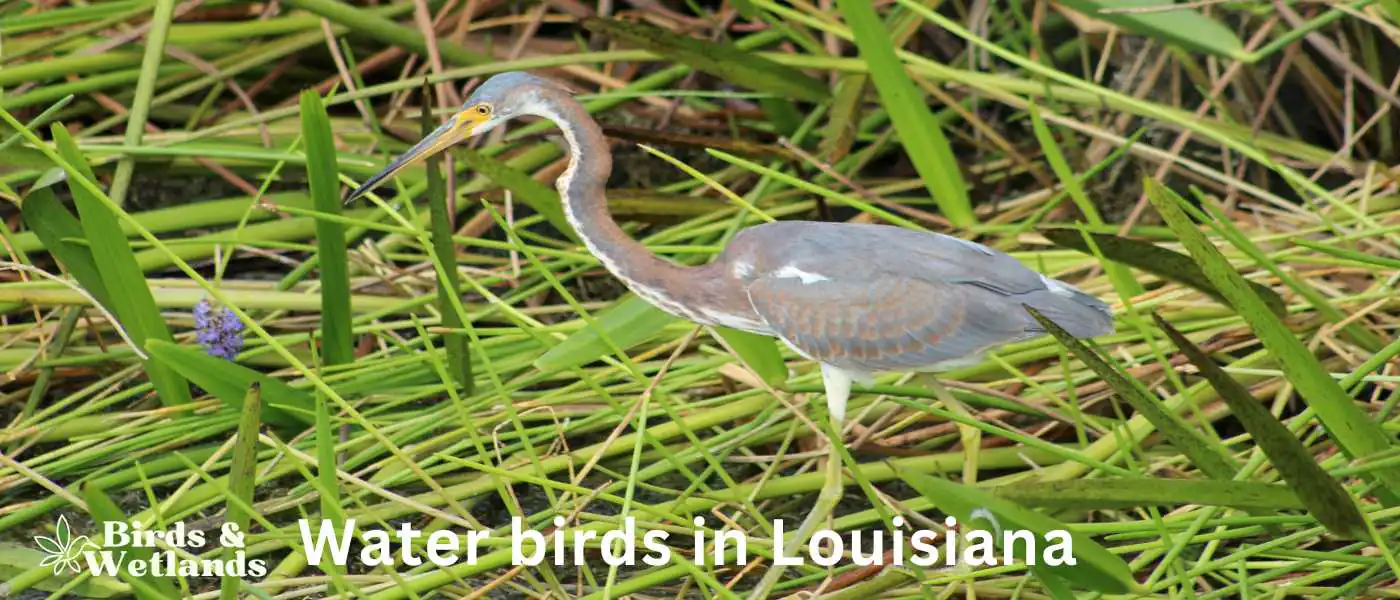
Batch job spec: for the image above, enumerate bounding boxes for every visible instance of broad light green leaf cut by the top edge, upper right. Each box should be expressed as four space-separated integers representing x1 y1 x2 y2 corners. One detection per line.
1061 0 1245 59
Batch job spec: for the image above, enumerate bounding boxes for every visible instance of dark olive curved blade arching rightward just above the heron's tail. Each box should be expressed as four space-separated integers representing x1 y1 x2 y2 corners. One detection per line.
1039 227 1288 316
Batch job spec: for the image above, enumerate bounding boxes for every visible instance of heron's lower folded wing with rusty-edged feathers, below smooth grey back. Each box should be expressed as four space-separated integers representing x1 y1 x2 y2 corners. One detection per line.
748 273 1033 372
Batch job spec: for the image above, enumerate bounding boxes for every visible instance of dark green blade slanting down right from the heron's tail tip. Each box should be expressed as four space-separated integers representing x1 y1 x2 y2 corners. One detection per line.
1026 306 1239 480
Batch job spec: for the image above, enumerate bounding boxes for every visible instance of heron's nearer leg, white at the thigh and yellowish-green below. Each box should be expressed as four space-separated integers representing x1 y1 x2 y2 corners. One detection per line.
749 364 851 600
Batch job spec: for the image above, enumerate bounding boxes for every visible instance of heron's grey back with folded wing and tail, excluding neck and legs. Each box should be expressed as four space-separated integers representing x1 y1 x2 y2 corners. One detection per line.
725 221 1113 372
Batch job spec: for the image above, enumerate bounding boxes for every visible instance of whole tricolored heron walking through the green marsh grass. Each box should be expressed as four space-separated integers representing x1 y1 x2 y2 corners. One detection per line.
349 73 1113 585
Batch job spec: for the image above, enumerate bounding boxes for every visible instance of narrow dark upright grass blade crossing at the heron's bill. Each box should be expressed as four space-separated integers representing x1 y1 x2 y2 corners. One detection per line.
421 81 476 396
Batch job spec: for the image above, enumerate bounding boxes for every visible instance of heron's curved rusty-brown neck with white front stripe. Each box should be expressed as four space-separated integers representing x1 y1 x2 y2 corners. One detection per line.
532 91 746 323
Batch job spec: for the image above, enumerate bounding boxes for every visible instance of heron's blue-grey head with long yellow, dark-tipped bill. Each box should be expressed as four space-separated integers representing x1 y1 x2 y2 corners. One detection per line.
346 71 564 203
